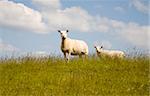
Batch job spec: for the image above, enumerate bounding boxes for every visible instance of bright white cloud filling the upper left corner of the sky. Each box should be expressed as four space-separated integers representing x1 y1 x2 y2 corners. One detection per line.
0 0 46 33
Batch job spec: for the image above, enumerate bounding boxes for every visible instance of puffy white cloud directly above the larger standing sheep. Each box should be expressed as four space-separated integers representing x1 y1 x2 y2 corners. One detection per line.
45 7 92 32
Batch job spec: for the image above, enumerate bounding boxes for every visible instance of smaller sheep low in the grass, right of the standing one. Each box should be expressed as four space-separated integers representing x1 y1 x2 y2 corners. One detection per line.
94 46 125 58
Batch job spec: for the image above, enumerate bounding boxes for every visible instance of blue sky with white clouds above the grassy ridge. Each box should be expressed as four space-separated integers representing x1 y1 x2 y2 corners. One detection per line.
0 0 150 57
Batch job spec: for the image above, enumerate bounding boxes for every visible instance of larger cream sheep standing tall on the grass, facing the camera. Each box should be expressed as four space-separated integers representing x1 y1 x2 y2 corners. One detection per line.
58 30 88 61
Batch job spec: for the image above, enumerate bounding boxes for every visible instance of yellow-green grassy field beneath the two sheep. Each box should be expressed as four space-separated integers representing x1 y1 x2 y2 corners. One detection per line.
0 57 150 96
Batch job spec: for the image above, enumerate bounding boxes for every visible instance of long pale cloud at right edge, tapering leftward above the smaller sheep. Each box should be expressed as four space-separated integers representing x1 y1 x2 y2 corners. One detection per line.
94 18 150 49
